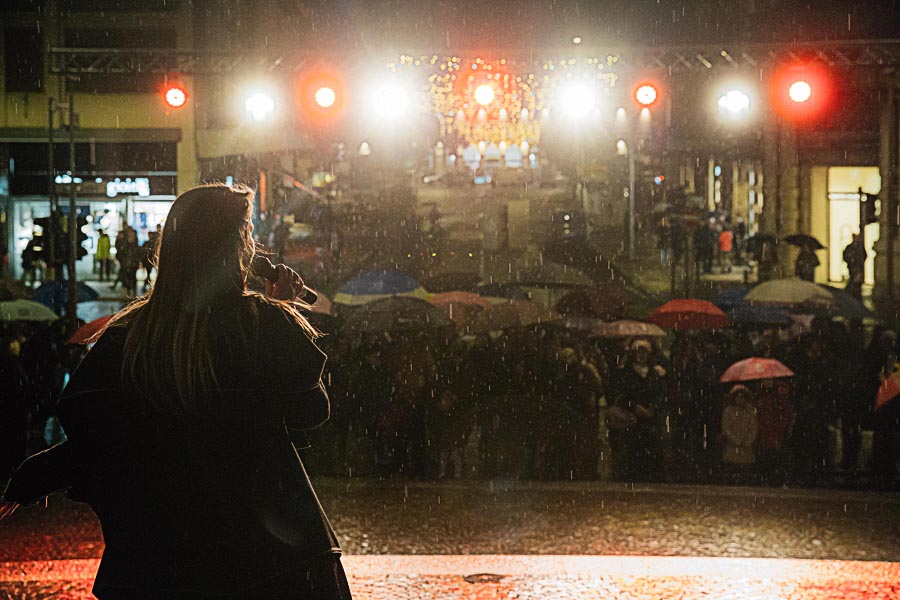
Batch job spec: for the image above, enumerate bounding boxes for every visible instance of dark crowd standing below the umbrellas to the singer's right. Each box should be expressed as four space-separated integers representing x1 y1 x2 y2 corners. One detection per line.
307 314 900 486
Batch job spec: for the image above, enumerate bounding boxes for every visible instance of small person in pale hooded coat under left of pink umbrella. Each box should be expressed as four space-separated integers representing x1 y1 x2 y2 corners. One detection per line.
722 385 759 483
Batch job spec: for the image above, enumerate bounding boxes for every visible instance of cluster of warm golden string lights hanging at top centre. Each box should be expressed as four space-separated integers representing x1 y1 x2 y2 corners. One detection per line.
387 54 618 145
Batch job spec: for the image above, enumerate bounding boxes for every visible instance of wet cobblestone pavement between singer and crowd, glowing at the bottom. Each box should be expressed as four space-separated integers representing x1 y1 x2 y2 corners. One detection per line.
0 480 900 600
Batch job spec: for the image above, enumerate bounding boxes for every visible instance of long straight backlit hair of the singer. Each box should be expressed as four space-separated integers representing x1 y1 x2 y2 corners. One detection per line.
110 184 317 413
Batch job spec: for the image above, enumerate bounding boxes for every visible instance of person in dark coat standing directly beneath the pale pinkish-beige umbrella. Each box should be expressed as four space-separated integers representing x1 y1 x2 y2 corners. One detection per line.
608 340 666 481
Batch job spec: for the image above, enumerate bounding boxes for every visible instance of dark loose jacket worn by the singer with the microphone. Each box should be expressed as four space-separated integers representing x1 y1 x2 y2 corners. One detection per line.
6 298 340 598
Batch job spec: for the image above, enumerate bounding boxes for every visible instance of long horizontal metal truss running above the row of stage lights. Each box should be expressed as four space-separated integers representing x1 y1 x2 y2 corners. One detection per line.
50 39 900 75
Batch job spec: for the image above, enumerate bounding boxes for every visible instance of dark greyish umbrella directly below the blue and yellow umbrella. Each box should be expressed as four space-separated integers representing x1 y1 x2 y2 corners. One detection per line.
341 297 453 333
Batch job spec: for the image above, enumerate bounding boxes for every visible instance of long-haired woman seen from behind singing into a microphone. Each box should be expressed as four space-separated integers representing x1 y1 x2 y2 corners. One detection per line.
0 185 350 600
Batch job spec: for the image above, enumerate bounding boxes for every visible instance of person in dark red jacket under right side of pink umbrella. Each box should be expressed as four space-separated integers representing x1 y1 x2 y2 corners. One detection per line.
756 379 795 487
